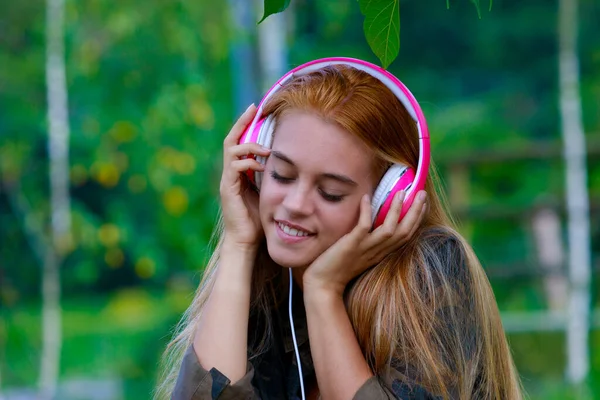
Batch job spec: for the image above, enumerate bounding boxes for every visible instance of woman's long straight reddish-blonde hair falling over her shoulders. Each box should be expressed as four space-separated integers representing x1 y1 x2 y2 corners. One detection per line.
155 66 522 400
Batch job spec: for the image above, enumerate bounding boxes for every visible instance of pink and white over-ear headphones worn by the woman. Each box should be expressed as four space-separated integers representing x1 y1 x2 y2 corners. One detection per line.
240 57 430 228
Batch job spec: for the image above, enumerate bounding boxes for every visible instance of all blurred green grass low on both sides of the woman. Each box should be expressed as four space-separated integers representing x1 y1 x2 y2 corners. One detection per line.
0 288 600 400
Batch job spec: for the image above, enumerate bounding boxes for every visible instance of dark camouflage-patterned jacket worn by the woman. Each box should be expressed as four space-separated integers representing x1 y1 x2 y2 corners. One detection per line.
172 231 464 400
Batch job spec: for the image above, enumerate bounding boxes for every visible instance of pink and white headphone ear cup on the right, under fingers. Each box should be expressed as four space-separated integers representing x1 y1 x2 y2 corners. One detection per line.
371 164 415 229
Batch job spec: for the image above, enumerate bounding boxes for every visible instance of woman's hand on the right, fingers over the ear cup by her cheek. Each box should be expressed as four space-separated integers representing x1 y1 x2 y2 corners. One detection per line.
302 191 427 296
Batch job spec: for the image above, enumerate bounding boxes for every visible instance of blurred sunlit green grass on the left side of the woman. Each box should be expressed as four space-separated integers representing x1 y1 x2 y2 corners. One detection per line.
1 289 192 400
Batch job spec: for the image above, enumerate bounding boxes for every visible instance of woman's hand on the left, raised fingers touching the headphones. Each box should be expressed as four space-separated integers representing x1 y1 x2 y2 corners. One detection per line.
219 104 270 250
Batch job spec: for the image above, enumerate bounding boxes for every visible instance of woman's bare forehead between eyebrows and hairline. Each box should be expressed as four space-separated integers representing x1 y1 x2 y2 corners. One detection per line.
272 112 372 177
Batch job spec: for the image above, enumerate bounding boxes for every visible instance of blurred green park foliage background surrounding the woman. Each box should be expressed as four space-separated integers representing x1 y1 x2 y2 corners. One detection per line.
0 0 600 400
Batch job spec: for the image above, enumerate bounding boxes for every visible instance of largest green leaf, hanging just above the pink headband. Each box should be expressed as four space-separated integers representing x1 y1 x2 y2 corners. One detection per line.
358 0 400 68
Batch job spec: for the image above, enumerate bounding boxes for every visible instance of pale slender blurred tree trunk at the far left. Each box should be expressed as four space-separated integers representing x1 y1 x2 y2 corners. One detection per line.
39 0 71 399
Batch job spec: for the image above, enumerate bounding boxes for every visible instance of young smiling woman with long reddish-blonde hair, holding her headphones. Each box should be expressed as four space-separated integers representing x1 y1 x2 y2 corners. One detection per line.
155 57 522 400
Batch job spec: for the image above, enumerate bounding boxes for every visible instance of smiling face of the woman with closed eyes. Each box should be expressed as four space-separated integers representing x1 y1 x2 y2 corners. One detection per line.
260 111 375 268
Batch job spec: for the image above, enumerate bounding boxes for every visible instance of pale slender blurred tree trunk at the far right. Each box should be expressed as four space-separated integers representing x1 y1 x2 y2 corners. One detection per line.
558 0 591 385
